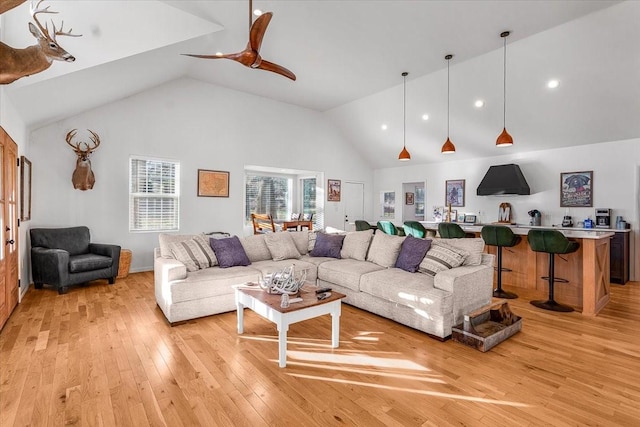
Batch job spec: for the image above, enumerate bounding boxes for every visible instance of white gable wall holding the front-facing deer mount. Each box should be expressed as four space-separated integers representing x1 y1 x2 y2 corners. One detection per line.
30 78 373 271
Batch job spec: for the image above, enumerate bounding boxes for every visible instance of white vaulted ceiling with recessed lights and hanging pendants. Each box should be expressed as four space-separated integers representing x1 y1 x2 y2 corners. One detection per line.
0 0 640 167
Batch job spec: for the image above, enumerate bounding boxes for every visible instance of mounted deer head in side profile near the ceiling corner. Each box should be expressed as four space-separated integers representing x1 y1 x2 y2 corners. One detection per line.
0 0 80 84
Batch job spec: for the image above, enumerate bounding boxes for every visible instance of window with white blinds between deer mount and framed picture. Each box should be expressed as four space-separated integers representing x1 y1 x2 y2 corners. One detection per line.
129 157 180 231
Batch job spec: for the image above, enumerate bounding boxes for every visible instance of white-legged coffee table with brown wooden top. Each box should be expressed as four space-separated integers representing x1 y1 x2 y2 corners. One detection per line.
236 284 345 368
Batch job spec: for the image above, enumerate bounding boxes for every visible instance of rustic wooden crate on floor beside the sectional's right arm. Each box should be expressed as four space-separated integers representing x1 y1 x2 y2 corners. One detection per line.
451 301 522 352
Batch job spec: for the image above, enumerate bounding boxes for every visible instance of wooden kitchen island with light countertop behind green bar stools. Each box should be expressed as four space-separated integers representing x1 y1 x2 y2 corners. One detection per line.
422 222 614 316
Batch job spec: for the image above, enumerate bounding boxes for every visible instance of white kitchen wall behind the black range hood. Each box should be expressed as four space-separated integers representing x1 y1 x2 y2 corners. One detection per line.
372 139 640 280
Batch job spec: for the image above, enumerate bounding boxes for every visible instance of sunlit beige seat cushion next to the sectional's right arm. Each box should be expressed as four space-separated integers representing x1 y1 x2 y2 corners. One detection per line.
360 268 453 317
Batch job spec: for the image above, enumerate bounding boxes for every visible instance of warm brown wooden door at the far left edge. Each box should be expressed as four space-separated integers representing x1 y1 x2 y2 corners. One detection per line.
0 127 19 328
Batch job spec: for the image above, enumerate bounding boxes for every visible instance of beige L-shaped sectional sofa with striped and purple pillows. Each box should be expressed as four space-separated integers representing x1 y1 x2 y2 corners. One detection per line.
154 230 494 339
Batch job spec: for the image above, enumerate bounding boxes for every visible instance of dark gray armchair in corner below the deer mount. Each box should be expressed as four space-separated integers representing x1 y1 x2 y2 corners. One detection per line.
30 227 120 294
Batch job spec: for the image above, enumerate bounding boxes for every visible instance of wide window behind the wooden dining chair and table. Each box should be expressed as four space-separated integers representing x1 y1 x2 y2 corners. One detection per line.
245 172 293 222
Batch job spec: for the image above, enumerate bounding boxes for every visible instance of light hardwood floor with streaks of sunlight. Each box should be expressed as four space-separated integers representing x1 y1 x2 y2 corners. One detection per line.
0 272 640 427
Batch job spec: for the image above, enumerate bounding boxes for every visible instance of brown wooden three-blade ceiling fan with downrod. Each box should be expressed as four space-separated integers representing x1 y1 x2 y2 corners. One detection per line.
183 0 296 80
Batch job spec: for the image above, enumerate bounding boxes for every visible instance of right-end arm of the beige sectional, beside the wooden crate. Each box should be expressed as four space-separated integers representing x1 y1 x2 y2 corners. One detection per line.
433 263 493 326
